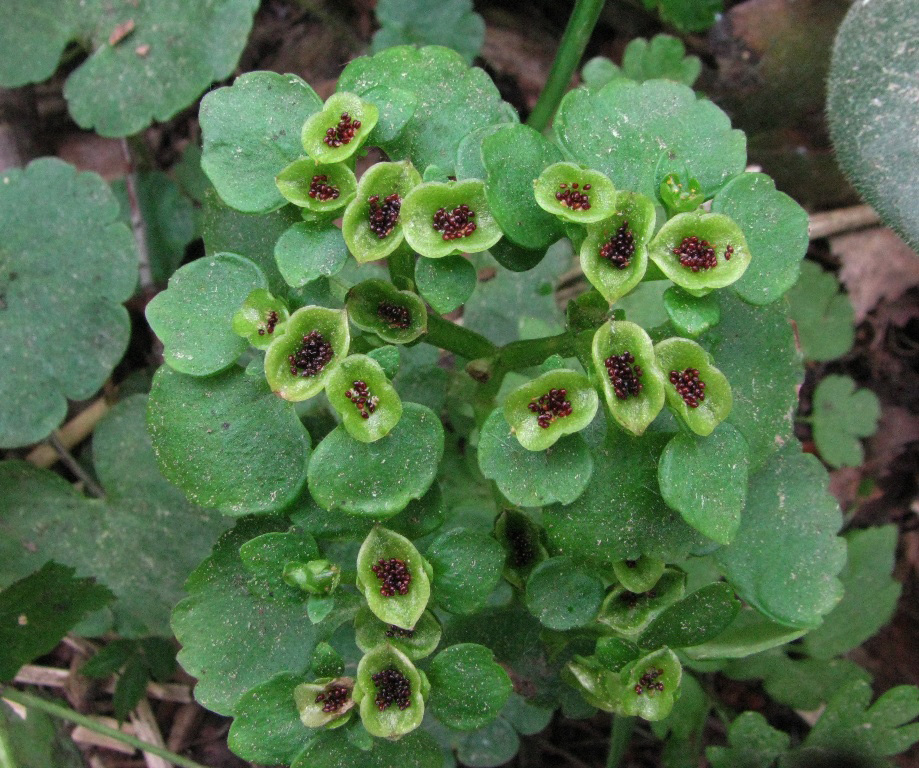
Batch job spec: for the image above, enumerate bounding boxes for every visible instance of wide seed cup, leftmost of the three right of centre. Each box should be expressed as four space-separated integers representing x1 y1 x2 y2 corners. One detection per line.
504 368 600 451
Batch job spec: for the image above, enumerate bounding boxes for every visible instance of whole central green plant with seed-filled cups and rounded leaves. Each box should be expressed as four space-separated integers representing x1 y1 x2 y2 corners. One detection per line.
144 47 868 768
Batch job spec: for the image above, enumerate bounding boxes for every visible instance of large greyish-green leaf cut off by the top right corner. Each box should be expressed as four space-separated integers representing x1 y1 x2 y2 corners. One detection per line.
827 0 919 249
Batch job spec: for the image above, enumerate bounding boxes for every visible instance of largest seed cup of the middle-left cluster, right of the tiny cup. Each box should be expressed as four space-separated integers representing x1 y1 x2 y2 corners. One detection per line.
265 306 351 402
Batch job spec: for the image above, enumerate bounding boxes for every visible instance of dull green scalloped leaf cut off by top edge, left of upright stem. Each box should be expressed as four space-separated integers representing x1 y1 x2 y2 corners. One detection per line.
371 0 485 64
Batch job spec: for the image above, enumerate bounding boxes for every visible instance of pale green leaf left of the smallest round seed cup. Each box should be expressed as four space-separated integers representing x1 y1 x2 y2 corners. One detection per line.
146 253 268 376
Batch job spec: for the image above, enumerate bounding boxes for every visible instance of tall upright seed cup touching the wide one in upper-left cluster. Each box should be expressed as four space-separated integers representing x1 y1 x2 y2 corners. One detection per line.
341 161 421 264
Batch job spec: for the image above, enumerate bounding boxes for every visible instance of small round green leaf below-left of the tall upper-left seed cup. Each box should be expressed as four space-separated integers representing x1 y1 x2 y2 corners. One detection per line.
274 222 348 288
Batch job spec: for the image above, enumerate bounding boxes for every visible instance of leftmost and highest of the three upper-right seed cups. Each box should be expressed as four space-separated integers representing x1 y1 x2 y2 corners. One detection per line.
533 163 616 224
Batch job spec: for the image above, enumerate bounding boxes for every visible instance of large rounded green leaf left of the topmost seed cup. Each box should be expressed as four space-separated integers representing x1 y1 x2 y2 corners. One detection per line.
199 72 322 213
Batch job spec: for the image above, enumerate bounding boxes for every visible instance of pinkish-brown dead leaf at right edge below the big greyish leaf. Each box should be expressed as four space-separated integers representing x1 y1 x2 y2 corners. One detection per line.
830 228 919 323
